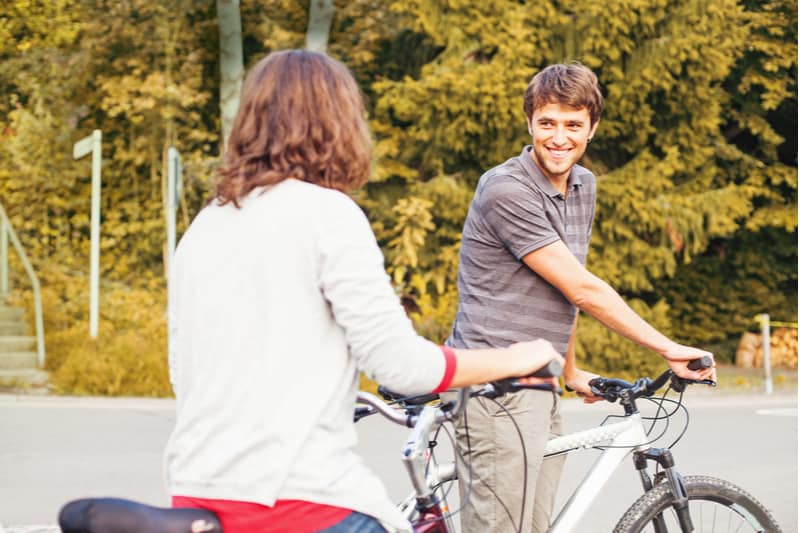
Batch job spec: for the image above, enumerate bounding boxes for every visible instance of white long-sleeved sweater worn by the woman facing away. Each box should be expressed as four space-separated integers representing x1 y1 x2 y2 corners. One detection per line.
165 179 445 531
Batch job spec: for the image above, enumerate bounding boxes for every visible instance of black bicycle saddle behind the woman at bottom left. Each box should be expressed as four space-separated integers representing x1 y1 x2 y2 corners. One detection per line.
58 498 222 533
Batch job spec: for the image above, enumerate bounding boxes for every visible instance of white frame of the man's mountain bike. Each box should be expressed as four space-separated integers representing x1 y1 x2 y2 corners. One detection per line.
545 413 648 533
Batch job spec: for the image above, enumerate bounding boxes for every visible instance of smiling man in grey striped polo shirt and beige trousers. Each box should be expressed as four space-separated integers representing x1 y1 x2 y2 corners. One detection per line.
447 63 714 533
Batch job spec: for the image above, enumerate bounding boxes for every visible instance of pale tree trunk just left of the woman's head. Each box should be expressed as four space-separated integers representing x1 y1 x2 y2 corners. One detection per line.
217 0 244 153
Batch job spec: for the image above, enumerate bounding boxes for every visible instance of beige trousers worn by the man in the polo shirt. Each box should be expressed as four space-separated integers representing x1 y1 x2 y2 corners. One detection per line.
446 390 565 533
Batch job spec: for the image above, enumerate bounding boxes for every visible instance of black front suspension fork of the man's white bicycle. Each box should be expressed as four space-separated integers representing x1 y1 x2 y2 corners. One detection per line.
633 448 694 533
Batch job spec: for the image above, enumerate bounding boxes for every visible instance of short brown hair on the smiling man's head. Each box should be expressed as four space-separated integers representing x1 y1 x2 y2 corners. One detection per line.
523 63 603 124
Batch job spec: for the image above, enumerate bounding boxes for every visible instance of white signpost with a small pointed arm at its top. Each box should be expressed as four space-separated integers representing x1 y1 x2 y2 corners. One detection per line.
72 130 103 339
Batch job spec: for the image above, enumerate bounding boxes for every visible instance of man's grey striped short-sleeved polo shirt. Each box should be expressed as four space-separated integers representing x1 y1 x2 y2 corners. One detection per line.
447 146 597 354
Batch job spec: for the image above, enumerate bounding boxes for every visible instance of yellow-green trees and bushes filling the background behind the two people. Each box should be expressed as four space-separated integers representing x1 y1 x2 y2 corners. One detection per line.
0 0 798 394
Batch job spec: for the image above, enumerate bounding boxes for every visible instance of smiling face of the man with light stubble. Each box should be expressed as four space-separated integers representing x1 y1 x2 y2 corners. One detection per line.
528 104 597 182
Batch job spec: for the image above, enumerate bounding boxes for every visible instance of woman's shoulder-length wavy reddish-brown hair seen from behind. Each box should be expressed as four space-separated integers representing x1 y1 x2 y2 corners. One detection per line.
216 50 371 207
